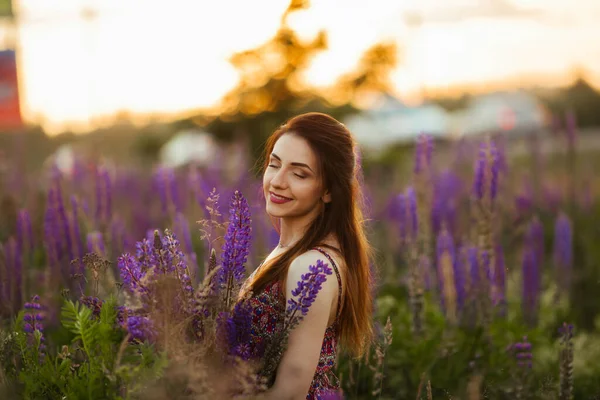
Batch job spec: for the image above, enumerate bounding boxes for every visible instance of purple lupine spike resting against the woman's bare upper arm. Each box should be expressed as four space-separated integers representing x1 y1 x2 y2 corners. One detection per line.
285 260 333 329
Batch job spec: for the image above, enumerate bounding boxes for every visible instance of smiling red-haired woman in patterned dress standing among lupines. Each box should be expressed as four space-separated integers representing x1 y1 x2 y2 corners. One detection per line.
242 113 373 400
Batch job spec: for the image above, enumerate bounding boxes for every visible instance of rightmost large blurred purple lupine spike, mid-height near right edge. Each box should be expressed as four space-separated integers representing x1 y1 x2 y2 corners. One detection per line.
553 213 573 291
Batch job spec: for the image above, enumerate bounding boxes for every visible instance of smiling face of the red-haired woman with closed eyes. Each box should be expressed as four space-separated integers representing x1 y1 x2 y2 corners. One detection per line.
263 133 331 219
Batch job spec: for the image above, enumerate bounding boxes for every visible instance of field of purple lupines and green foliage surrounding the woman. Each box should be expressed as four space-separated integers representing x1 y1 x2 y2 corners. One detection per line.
0 118 600 400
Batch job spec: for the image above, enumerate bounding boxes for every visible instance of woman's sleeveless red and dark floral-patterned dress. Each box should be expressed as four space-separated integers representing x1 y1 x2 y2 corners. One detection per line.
239 247 342 400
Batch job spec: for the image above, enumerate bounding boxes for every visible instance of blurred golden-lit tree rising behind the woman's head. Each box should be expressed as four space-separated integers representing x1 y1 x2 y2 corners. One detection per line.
178 0 397 166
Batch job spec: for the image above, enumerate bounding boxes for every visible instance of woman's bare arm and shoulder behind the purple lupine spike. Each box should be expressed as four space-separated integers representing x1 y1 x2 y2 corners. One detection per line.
266 251 338 400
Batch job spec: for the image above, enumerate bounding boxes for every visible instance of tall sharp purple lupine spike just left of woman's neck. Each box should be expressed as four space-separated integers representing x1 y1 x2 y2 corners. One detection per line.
218 190 252 285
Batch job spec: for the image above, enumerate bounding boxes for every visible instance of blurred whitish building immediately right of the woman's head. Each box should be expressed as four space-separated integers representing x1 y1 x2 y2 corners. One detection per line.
344 96 450 150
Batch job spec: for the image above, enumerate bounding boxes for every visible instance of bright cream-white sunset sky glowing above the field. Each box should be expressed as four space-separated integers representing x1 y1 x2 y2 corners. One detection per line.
0 0 600 133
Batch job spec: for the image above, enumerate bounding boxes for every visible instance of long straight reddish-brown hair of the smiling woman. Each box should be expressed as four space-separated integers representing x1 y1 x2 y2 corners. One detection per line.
248 112 373 357
